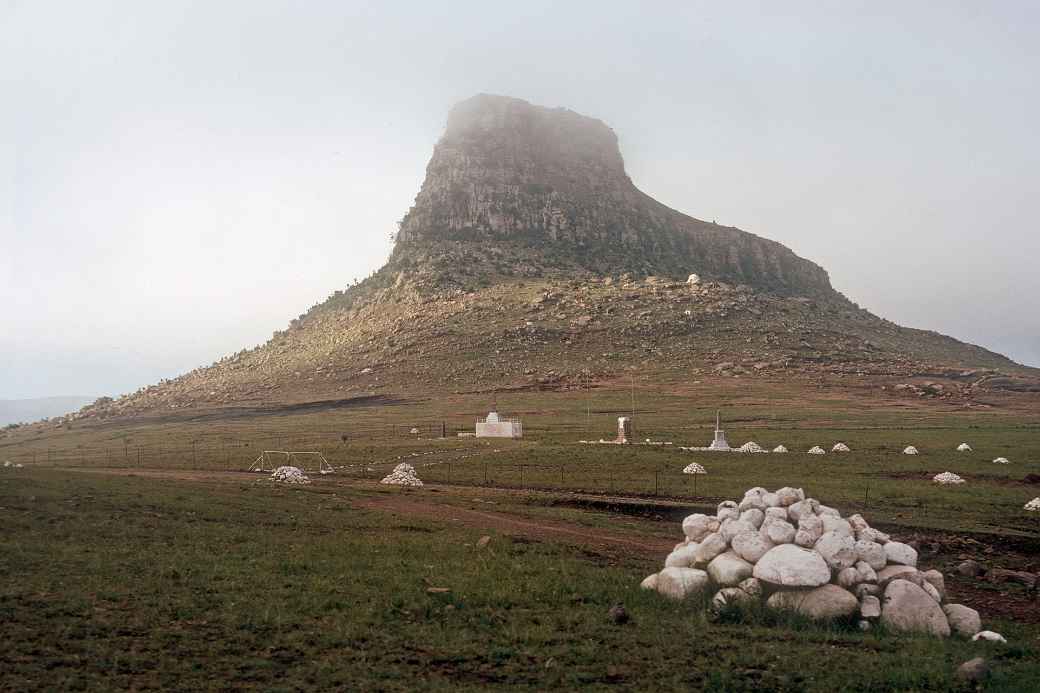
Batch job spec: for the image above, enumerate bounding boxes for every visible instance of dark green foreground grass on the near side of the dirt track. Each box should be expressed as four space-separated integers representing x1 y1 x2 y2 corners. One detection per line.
0 469 1040 691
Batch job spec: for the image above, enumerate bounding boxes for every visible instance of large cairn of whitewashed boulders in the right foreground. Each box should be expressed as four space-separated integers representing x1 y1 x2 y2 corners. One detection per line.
642 487 998 637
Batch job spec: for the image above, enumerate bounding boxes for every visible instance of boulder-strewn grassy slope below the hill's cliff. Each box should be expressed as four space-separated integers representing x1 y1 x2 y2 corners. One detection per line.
69 271 1037 413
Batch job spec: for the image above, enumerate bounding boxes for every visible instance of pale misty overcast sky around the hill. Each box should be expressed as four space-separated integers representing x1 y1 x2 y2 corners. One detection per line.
0 0 1040 399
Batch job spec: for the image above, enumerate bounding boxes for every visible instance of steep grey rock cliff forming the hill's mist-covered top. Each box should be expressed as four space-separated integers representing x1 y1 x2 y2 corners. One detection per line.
394 95 833 297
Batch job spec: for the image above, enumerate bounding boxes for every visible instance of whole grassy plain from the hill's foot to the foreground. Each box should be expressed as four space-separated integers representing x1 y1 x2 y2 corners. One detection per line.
0 385 1040 691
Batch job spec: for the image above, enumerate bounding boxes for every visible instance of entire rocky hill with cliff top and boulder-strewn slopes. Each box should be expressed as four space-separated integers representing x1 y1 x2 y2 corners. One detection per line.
60 95 1040 418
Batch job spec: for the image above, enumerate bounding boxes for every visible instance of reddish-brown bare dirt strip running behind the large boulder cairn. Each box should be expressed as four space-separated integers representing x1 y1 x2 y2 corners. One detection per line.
59 467 1040 623
